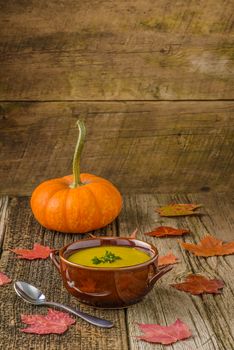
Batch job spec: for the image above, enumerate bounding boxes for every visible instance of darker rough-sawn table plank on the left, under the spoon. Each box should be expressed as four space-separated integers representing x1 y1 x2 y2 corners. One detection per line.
0 198 128 350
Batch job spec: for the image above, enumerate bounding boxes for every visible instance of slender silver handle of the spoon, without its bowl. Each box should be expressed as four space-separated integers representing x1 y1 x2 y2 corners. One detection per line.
43 301 114 328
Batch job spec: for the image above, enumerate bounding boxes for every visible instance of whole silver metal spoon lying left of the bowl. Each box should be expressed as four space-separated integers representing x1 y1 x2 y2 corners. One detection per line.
14 281 113 328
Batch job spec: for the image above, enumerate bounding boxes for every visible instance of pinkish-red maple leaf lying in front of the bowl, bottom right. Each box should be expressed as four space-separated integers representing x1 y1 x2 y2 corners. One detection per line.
137 319 192 345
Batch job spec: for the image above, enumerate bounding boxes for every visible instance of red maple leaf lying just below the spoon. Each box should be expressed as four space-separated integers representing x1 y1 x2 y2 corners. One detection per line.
20 309 75 334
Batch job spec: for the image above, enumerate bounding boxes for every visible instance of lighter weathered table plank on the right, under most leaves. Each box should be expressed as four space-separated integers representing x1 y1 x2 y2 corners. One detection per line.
119 194 234 350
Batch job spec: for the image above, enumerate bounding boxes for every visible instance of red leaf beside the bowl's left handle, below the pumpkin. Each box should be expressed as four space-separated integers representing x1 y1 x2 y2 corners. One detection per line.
10 243 53 260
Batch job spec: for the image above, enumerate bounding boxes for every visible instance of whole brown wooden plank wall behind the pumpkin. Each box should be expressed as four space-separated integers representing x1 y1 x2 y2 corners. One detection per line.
0 0 234 195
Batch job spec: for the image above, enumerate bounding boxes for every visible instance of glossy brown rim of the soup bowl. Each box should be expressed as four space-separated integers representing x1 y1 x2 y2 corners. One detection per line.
59 236 159 272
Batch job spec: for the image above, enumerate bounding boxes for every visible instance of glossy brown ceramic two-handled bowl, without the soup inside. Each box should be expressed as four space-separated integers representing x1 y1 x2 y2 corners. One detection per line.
50 237 172 308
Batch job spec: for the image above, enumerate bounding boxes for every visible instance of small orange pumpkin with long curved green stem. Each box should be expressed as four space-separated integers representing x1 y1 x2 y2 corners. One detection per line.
31 120 122 233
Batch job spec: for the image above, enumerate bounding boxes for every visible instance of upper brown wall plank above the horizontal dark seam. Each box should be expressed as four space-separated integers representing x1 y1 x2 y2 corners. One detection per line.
0 0 234 101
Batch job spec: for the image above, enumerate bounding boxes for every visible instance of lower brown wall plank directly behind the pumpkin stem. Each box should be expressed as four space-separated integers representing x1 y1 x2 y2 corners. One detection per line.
0 102 234 195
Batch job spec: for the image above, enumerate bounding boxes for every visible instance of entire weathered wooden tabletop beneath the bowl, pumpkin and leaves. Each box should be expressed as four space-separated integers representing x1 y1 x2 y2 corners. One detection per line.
0 194 234 350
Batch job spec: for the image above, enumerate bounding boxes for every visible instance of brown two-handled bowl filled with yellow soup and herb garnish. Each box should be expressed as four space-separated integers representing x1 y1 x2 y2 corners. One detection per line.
50 237 172 308
